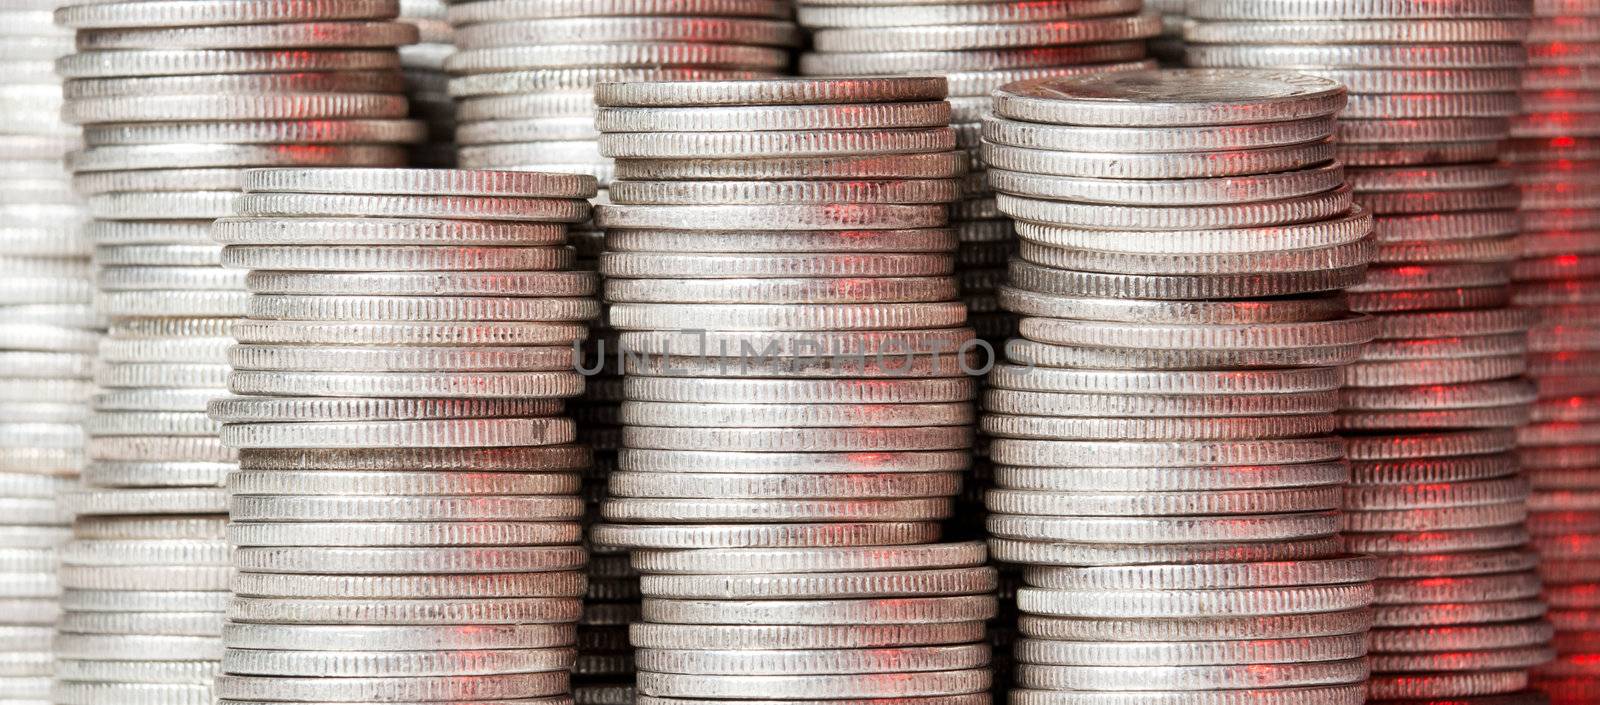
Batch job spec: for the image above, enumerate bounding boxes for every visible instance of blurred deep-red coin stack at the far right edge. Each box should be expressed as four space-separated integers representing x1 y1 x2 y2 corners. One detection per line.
1504 0 1600 705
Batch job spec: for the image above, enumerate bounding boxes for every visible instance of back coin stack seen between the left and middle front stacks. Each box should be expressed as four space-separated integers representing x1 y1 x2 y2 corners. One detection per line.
445 0 800 187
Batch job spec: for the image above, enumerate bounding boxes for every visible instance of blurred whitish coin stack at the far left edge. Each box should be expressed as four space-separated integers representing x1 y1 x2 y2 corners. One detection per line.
0 0 86 693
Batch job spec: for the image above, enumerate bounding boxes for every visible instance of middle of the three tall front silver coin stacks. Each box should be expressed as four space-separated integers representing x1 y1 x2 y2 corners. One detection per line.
592 78 997 705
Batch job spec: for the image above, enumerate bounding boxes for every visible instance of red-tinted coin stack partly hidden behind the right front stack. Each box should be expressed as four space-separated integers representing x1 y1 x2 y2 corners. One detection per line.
1186 0 1549 702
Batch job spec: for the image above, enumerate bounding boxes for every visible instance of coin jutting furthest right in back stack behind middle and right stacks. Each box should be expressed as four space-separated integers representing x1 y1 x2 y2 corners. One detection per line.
811 13 1162 54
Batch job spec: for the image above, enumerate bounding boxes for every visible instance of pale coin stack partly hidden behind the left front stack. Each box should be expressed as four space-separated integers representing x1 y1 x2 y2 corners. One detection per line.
54 0 421 705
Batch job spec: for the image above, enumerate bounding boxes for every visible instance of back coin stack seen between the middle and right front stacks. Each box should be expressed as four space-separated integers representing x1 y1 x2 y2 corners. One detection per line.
795 0 1160 344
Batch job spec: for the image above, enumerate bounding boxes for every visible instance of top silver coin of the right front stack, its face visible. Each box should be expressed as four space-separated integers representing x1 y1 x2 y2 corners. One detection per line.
994 69 1344 126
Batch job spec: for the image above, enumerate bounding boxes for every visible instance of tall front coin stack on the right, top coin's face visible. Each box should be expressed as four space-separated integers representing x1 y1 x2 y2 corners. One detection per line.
981 70 1376 705
